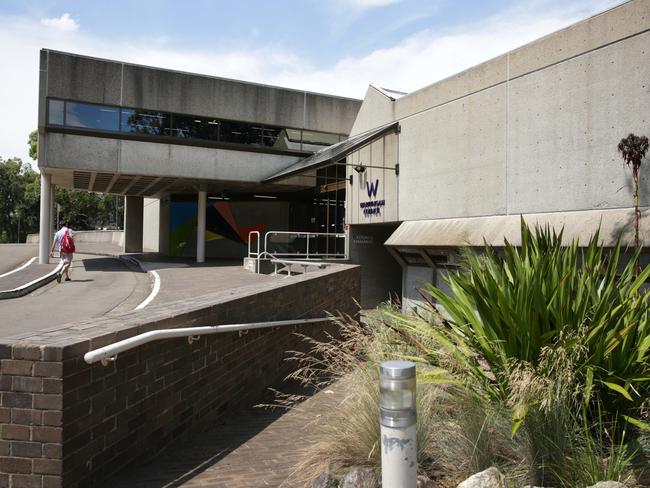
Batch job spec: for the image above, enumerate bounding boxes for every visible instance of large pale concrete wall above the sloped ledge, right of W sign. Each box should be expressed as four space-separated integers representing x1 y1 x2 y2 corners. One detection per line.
348 0 650 222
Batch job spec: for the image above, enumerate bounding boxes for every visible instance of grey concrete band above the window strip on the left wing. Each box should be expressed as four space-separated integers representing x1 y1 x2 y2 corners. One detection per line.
40 49 361 134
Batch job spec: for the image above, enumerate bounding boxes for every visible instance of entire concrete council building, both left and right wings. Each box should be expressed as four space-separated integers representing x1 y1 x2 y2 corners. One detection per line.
39 0 650 306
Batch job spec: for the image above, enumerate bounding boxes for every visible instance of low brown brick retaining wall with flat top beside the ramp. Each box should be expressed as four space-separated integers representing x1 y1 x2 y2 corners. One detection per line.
0 265 360 488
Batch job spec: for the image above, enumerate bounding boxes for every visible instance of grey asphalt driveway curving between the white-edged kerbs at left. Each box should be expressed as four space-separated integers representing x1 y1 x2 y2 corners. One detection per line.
0 254 150 337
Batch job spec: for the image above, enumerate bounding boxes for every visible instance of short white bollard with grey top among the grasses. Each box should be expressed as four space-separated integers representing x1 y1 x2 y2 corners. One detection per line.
379 361 418 488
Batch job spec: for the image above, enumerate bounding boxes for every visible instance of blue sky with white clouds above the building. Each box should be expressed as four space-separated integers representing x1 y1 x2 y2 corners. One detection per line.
0 0 622 166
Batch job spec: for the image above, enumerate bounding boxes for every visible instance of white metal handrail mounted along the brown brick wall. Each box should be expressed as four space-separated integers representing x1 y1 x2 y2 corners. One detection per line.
84 317 333 366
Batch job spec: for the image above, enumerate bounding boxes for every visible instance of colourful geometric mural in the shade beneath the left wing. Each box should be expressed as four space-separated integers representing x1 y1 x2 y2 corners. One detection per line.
169 200 268 256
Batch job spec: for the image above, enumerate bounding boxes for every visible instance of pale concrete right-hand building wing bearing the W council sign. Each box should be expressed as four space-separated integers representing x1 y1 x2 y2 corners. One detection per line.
269 0 650 305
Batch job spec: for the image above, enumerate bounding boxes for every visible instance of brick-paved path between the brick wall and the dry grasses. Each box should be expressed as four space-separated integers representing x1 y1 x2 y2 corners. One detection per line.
104 383 344 488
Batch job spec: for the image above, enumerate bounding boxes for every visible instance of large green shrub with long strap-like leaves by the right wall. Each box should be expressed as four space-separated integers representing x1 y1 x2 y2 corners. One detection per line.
393 220 650 426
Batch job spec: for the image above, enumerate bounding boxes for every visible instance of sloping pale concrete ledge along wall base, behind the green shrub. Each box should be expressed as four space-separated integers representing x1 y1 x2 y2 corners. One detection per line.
385 207 650 248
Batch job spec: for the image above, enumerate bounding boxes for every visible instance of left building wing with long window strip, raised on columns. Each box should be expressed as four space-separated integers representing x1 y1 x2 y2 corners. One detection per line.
38 49 360 262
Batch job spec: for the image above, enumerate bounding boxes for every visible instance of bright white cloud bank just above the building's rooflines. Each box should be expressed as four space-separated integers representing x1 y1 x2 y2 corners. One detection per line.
0 0 614 166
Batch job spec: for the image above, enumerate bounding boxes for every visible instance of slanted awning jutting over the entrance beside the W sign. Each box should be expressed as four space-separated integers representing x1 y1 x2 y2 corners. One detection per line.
262 122 399 183
